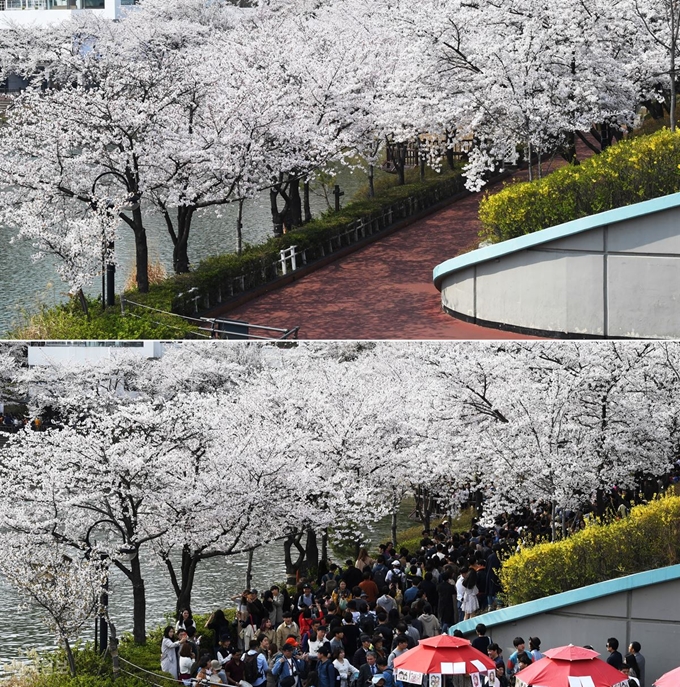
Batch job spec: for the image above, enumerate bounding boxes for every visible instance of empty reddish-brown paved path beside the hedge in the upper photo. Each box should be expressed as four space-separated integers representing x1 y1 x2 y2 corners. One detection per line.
216 155 588 339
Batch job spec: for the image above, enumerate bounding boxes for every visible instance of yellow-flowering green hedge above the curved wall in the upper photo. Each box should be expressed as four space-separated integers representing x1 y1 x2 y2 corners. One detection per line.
479 129 680 243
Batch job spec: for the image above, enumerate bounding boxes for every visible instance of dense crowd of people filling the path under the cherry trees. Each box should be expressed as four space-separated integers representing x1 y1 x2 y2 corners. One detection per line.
161 509 645 687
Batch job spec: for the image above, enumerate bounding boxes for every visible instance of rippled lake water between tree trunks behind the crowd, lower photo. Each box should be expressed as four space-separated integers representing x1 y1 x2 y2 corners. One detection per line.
0 500 414 676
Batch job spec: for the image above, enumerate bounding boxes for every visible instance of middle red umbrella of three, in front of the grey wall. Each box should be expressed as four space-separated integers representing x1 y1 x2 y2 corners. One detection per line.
515 644 628 687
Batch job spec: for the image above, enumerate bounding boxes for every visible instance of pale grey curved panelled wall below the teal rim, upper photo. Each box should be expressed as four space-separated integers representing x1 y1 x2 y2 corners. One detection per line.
439 204 680 338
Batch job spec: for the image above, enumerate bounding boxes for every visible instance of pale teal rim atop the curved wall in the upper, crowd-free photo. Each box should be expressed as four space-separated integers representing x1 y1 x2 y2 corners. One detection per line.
432 193 680 290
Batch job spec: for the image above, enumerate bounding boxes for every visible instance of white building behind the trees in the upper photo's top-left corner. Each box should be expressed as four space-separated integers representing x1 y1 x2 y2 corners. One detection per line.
0 0 137 29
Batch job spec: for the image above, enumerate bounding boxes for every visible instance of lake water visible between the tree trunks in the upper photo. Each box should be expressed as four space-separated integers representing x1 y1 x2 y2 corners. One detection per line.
0 167 382 338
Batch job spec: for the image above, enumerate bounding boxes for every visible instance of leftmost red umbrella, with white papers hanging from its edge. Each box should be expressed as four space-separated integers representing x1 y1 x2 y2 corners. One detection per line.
394 635 495 682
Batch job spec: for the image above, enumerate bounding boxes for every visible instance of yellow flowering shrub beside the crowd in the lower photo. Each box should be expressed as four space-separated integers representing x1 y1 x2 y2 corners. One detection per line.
500 496 680 604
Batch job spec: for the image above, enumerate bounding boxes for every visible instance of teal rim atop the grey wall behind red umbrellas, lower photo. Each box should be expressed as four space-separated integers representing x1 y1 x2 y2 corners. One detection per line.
449 565 680 634
